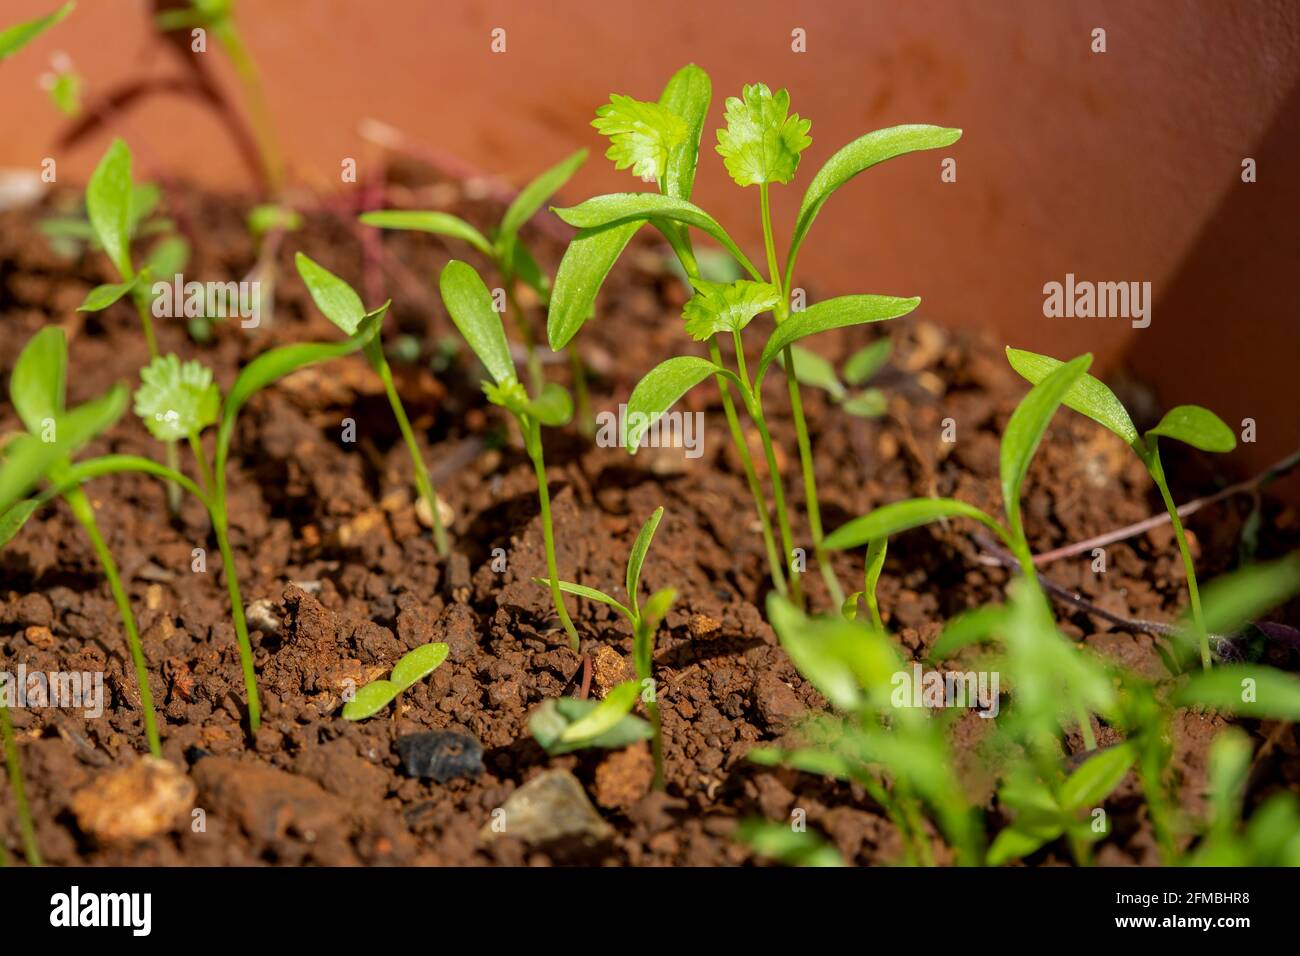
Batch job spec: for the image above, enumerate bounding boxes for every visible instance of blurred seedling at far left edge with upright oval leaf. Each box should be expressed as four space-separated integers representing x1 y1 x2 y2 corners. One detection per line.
0 326 163 757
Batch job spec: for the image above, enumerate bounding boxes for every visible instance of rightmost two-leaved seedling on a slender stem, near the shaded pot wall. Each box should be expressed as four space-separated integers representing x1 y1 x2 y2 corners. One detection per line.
1006 349 1236 667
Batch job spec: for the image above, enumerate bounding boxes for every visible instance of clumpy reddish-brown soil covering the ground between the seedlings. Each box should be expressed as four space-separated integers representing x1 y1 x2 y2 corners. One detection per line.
0 171 1300 865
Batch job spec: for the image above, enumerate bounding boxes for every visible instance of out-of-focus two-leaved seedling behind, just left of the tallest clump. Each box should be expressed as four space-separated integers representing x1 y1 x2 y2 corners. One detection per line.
360 150 592 408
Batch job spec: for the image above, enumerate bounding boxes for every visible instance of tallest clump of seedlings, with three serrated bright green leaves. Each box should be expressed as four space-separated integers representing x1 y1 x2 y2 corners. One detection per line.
547 66 961 604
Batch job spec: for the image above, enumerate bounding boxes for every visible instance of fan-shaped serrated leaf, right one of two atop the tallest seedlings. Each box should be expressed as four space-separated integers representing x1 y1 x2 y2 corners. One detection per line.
716 83 813 186
